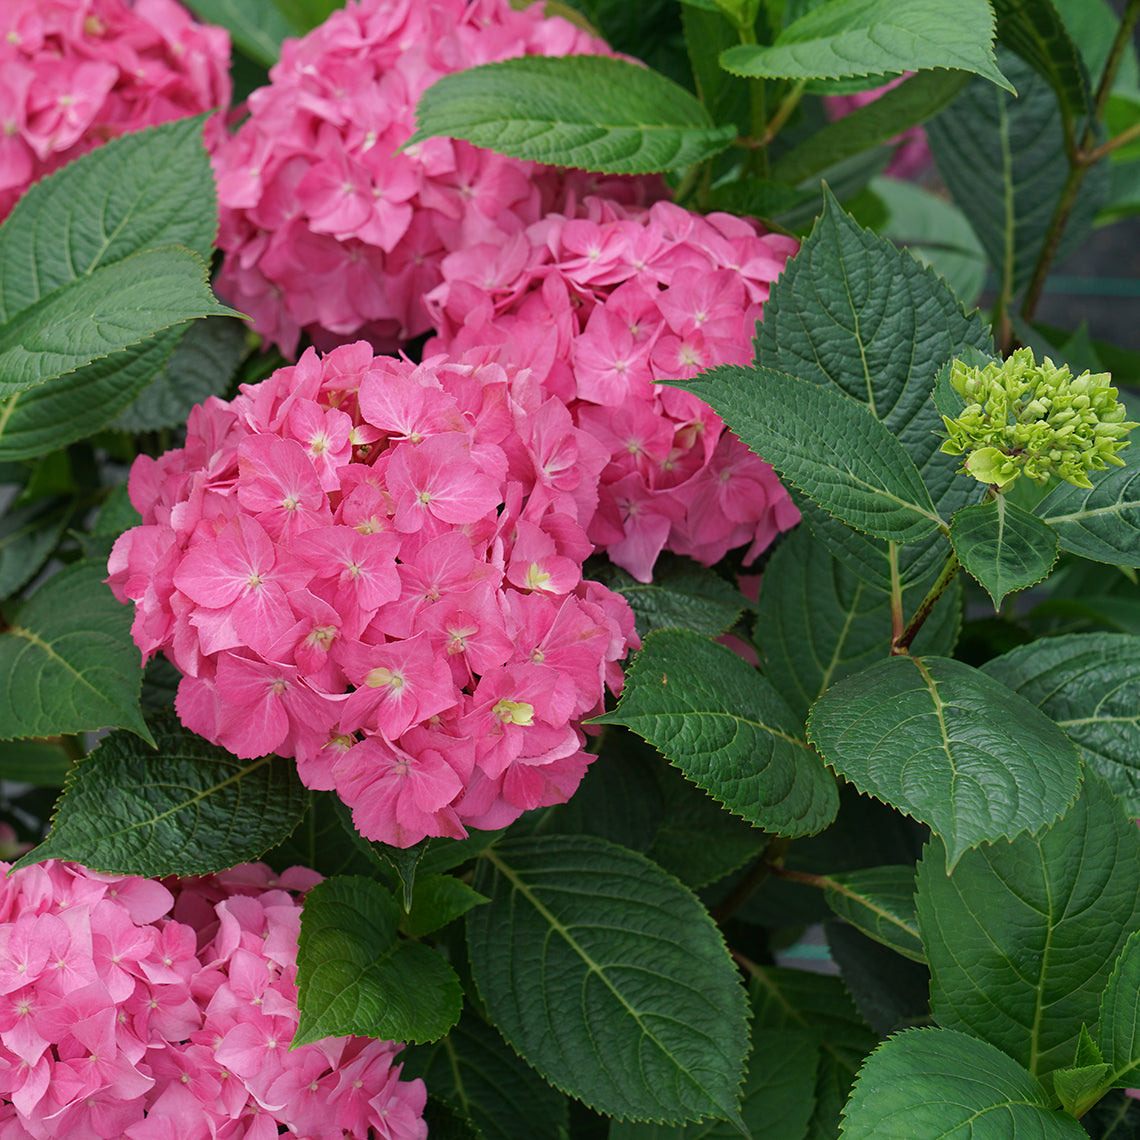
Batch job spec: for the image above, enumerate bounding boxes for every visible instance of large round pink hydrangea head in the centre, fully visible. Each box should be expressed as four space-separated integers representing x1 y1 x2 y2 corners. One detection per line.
109 341 636 846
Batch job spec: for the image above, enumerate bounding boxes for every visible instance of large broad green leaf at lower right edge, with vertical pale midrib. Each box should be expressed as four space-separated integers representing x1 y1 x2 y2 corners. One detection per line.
918 772 1140 1077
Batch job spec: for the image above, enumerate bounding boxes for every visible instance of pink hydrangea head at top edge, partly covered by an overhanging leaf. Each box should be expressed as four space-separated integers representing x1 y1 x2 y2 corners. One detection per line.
213 0 658 358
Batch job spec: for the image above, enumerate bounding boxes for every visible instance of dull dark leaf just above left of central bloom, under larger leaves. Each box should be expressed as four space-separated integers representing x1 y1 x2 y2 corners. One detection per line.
114 319 245 432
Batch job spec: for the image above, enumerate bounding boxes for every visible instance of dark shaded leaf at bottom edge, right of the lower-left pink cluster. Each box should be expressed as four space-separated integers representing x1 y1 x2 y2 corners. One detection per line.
401 1010 569 1140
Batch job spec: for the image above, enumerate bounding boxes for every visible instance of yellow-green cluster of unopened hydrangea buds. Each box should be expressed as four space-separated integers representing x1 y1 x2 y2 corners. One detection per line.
942 349 1138 487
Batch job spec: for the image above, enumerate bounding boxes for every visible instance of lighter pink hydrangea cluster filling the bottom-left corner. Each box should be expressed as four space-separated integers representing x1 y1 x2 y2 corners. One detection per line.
0 861 428 1140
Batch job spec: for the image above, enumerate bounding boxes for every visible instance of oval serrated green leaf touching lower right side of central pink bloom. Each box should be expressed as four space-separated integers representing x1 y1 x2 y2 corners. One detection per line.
594 629 839 836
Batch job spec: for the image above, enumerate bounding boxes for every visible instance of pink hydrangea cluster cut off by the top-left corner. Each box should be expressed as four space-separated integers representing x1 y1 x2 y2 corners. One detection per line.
0 0 230 220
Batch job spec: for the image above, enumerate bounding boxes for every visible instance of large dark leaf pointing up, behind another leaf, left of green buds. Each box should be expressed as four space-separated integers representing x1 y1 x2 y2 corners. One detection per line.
756 195 992 589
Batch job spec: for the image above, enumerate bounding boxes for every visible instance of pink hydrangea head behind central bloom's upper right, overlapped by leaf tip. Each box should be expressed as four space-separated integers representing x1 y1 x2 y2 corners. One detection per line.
425 197 799 581
